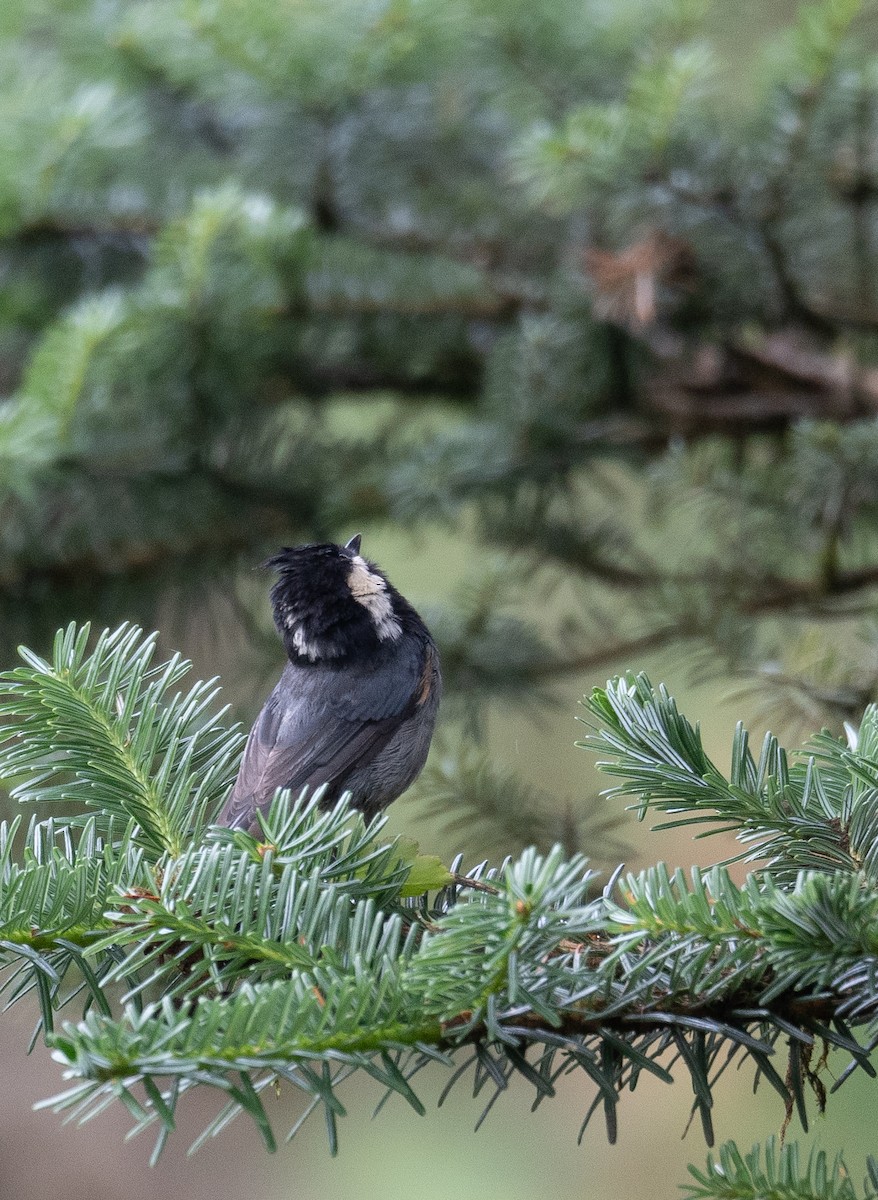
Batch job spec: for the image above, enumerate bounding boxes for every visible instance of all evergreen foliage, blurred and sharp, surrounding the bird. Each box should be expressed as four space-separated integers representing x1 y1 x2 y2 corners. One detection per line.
6 0 878 1196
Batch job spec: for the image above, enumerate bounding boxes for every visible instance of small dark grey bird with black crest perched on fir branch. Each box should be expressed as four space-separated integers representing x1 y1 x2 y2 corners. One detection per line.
220 534 441 830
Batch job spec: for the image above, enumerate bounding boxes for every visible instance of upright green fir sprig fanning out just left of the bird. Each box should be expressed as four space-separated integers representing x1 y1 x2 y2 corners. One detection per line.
0 625 242 854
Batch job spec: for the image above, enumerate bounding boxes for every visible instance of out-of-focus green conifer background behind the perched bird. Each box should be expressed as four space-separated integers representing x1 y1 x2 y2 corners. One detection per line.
0 0 878 1200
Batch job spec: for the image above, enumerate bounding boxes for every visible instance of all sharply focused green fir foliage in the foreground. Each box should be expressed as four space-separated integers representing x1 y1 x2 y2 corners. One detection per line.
0 625 878 1200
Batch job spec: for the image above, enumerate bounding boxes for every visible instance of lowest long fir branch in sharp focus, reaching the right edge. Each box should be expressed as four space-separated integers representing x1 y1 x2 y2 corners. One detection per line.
39 856 874 1156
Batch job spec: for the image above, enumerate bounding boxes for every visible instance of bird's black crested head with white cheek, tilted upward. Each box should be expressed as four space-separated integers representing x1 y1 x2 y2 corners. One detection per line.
265 534 409 662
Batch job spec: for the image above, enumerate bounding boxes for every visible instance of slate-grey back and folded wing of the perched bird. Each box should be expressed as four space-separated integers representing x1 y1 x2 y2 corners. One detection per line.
220 648 433 829
